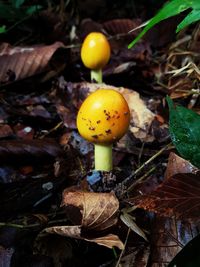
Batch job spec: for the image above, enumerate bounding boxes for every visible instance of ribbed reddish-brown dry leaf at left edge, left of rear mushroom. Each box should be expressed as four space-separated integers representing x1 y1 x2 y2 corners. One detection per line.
0 42 63 84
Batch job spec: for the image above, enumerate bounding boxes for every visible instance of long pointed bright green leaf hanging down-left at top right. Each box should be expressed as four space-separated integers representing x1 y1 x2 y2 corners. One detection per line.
128 0 193 48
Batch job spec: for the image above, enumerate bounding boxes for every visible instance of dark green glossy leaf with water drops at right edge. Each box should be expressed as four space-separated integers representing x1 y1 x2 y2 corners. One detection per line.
167 97 200 168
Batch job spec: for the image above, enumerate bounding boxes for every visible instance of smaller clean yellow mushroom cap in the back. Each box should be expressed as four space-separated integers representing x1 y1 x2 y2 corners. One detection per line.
81 32 110 70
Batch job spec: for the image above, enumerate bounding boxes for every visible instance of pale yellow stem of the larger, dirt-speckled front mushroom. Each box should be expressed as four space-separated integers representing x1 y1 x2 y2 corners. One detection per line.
94 144 112 171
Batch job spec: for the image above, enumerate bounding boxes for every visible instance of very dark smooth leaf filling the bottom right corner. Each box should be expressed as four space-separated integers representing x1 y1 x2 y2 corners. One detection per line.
168 235 200 267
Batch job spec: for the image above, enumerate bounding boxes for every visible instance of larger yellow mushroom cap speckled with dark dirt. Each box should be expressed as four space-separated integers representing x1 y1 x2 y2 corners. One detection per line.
77 89 130 144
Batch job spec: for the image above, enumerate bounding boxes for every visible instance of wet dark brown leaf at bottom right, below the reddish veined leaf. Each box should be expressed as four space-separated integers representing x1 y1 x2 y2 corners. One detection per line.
150 216 198 267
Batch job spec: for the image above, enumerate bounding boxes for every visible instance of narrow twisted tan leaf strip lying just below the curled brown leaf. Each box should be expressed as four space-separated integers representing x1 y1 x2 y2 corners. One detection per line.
44 225 124 249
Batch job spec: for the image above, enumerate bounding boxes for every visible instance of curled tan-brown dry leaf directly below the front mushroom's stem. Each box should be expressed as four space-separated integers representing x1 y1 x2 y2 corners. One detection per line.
62 190 119 231
